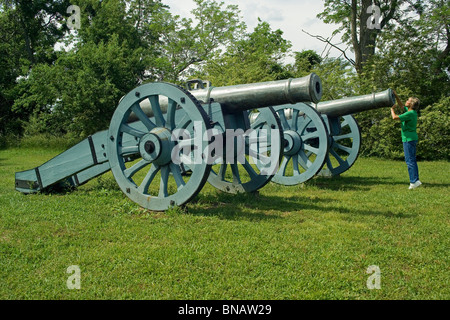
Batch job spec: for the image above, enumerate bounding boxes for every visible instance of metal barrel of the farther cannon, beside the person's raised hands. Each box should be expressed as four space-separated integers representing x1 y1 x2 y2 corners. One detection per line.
316 89 395 117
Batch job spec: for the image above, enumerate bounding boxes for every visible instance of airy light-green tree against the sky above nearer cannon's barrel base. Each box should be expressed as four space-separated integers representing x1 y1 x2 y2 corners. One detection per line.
153 0 246 82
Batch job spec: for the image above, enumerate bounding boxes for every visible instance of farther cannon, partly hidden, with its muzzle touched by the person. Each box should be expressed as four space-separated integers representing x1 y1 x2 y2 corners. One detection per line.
252 89 395 185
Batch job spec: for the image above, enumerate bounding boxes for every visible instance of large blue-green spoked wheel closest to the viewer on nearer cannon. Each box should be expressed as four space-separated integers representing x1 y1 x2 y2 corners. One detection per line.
107 83 211 211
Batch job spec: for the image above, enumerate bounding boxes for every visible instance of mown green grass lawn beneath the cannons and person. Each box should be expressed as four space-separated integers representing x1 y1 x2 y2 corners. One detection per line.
0 148 450 299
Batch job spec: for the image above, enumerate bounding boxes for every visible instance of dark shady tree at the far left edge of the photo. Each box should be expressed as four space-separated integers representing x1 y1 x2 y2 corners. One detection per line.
0 0 69 136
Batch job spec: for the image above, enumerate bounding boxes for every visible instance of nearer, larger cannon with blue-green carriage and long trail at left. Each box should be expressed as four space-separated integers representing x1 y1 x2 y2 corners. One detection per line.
15 74 322 211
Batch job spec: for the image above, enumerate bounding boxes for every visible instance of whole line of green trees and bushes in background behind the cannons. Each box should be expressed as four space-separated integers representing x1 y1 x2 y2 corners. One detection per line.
0 0 450 159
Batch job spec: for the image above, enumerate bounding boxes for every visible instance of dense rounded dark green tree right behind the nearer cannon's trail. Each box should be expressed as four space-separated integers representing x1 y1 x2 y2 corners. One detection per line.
14 35 149 139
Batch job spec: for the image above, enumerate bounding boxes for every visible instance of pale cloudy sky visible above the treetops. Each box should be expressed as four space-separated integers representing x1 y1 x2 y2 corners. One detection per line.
162 0 351 62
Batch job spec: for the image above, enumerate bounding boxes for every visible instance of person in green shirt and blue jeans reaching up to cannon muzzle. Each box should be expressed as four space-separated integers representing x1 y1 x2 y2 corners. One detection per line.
391 90 422 189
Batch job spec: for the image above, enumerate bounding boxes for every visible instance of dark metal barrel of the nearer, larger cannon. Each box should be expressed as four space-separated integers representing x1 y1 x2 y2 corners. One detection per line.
129 73 322 122
